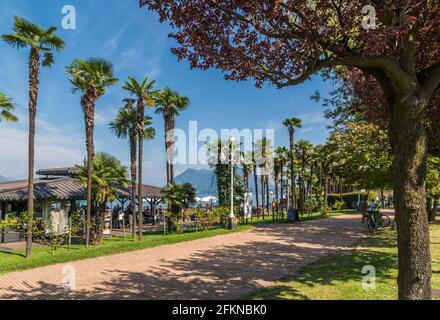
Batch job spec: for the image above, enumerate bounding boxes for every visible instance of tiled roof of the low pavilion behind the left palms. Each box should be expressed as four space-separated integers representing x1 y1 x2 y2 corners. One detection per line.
0 177 161 201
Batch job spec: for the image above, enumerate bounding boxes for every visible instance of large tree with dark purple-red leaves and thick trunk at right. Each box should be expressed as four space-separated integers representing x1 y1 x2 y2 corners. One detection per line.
140 0 440 299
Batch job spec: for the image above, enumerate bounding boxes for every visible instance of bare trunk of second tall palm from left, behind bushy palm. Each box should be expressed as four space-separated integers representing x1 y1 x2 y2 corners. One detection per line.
81 86 98 248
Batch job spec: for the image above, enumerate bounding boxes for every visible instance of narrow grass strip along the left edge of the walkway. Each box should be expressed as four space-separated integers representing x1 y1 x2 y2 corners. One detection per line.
0 225 254 274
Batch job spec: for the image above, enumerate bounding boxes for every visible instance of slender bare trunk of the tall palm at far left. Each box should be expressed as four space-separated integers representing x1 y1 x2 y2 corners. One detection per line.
26 48 40 258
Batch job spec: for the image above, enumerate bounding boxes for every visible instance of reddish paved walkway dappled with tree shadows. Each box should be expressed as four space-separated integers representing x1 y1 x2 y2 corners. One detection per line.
0 215 367 299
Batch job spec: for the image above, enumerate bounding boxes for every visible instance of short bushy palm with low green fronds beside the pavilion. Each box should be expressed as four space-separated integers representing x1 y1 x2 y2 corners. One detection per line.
78 152 128 245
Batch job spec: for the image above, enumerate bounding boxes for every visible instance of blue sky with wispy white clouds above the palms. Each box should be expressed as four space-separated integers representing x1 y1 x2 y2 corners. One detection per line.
0 0 331 185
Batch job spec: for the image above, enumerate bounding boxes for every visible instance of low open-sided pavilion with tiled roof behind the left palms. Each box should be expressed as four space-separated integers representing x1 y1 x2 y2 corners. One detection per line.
0 167 162 243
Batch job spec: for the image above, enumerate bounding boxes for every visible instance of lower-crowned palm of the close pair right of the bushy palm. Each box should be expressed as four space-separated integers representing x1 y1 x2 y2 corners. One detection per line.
110 99 156 238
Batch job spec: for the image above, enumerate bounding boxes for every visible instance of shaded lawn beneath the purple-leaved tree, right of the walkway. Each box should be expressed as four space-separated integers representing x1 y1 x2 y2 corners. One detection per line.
247 222 440 300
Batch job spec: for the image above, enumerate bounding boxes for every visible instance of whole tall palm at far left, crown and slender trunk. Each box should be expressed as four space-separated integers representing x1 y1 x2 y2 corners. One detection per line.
2 17 64 258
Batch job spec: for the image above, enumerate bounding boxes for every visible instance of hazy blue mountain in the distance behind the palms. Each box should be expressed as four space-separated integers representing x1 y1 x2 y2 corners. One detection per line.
174 169 217 197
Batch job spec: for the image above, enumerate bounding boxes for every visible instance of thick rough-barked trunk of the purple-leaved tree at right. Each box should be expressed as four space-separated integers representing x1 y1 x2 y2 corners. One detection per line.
390 100 431 299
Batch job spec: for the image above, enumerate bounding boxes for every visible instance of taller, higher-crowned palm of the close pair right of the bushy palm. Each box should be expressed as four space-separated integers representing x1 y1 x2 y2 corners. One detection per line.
122 77 157 241
